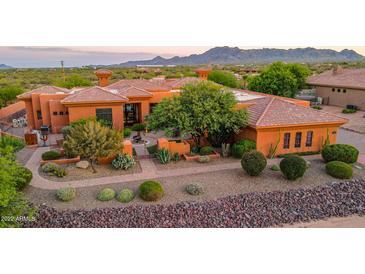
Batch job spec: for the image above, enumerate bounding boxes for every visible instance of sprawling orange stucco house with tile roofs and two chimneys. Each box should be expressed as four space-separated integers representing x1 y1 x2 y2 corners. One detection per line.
18 70 347 155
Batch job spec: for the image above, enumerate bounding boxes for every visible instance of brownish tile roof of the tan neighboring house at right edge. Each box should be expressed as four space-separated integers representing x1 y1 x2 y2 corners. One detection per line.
307 68 365 89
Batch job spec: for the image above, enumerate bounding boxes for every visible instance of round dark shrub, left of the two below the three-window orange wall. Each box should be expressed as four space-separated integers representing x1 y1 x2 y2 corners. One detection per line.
241 150 267 176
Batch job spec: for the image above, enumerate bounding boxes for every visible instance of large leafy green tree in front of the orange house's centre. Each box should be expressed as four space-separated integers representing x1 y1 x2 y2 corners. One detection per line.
147 81 247 145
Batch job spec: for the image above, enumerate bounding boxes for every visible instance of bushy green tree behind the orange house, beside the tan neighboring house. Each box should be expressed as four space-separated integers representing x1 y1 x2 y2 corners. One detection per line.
247 62 310 98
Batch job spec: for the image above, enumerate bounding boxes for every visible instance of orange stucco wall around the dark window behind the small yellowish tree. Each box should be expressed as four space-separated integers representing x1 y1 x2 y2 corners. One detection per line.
68 105 123 130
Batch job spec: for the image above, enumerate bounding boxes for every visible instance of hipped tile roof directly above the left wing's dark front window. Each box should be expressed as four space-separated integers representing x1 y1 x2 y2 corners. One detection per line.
61 86 128 104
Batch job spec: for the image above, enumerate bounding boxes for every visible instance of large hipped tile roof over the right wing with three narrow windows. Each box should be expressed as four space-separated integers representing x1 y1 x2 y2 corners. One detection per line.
248 96 347 127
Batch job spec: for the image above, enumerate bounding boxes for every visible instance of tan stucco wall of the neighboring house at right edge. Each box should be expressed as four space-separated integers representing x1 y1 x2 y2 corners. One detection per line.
316 87 365 110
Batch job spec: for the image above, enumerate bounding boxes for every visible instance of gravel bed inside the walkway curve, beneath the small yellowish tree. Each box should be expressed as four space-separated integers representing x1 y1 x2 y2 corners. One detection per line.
38 161 142 182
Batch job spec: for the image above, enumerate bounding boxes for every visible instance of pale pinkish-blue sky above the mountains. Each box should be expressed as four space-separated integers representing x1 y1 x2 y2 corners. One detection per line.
0 46 365 68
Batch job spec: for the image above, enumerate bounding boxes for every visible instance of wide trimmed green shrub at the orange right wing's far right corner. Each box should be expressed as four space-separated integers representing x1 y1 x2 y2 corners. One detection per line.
322 144 359 164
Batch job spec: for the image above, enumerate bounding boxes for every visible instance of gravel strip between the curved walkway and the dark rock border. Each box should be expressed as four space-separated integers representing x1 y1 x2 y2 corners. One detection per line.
26 159 365 209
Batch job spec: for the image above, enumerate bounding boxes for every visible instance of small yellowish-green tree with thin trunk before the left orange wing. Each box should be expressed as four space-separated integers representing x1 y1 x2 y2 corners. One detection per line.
63 120 123 173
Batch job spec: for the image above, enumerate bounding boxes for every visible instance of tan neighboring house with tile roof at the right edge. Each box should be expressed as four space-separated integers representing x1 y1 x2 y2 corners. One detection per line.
307 66 365 110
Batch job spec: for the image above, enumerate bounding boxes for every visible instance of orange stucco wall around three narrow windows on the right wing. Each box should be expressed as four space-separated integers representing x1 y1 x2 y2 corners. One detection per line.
252 125 339 155
